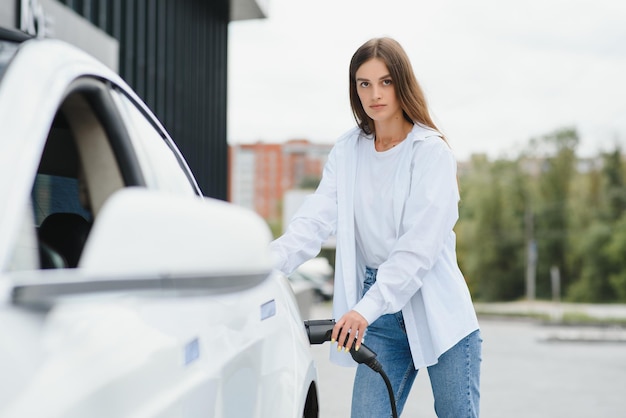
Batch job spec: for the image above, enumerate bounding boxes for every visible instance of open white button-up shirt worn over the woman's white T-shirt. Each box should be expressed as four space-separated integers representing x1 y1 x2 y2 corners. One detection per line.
271 125 479 369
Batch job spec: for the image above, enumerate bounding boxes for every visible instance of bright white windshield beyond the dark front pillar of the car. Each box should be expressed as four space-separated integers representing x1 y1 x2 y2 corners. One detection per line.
112 91 198 195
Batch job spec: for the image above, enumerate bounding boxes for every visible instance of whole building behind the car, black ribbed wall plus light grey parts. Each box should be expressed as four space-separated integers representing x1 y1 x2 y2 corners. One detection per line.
0 0 269 200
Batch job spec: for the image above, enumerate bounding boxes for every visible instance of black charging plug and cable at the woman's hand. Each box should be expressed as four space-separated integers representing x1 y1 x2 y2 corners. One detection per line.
304 319 398 418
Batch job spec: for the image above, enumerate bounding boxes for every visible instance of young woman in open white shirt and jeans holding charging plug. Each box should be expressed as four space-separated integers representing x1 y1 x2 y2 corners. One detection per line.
271 38 482 418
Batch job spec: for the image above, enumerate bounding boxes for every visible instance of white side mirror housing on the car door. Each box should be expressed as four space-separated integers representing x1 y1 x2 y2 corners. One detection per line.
79 188 273 277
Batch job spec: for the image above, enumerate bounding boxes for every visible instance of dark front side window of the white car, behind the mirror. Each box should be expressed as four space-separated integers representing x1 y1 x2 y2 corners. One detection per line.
31 83 138 269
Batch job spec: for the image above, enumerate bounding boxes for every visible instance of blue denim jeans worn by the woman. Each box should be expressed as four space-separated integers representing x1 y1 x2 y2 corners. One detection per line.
352 267 482 418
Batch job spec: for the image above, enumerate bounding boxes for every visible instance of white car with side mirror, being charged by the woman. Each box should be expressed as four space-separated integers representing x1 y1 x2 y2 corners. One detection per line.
0 30 318 418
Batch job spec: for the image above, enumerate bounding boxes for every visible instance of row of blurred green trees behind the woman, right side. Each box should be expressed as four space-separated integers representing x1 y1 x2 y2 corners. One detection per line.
455 128 626 302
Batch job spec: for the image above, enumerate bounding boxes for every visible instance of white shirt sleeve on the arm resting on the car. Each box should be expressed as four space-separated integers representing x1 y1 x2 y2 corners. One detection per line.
270 145 337 274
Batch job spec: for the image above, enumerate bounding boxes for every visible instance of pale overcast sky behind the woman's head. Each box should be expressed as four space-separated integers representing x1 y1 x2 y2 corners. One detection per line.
228 0 626 159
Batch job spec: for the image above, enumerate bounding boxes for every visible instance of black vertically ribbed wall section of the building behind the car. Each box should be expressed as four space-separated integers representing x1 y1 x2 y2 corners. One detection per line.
60 0 230 200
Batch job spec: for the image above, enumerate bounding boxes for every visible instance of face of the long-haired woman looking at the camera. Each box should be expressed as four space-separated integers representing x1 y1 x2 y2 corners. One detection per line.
355 58 403 122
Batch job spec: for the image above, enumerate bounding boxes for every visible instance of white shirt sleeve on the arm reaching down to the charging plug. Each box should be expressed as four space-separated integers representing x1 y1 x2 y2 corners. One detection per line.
354 138 459 324
